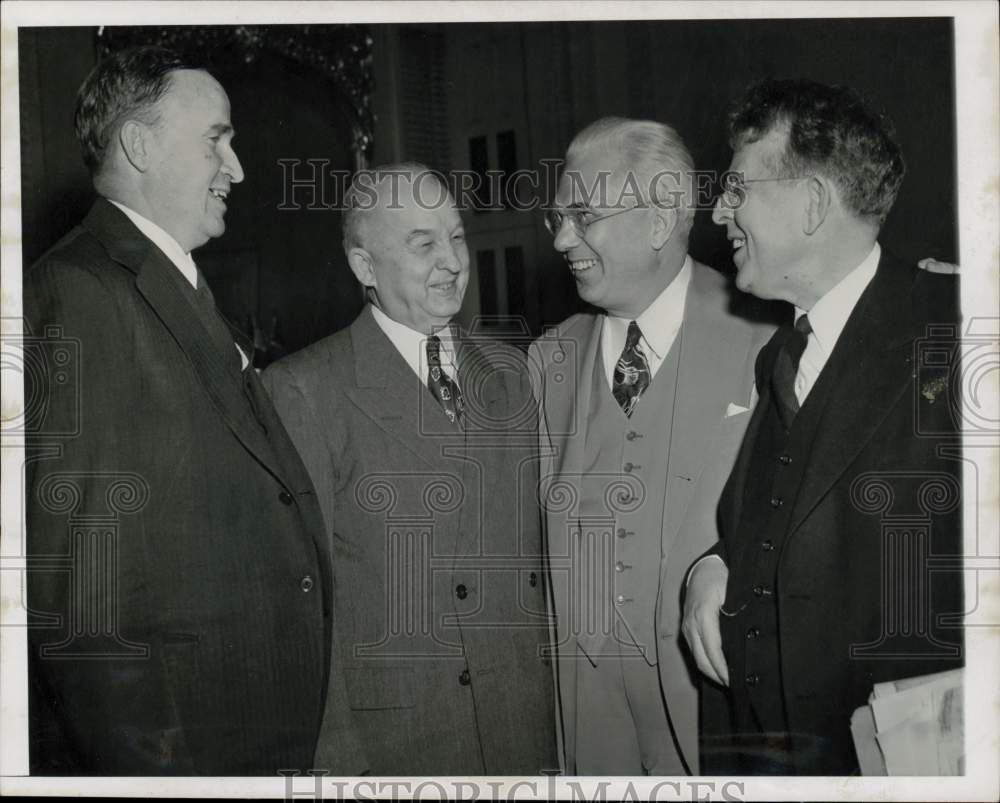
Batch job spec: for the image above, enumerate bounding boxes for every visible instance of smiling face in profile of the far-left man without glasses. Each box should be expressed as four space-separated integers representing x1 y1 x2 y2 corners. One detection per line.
142 70 243 251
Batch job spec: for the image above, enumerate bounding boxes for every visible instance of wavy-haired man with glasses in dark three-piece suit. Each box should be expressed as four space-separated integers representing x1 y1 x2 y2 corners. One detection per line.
684 81 963 775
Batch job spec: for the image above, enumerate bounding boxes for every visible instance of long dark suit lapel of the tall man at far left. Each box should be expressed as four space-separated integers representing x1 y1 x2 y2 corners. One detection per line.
84 199 282 479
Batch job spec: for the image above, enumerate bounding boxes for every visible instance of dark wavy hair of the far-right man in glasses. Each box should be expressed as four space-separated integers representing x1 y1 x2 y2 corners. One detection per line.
729 80 906 226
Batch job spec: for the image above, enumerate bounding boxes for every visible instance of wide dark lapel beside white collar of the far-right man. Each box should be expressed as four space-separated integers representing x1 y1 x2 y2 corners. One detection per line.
789 254 914 532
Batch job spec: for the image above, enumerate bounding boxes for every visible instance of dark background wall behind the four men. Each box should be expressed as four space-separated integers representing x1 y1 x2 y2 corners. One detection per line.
18 18 958 350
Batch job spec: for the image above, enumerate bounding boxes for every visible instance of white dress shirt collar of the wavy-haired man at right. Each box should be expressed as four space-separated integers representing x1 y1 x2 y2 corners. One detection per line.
795 243 882 406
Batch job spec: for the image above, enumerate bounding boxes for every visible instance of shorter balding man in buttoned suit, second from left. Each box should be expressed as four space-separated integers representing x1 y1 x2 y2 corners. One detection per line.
264 164 556 775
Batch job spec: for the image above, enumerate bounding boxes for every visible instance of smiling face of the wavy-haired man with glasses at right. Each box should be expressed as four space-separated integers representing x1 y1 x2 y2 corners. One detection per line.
712 130 808 303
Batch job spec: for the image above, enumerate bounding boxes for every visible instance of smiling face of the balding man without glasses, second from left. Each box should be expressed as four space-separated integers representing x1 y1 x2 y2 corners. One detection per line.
347 173 469 334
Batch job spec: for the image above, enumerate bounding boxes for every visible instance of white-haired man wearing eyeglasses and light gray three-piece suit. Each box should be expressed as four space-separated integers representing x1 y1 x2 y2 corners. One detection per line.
532 118 770 775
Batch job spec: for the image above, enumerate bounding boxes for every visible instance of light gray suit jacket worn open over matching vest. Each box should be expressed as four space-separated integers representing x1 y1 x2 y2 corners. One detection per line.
529 262 773 773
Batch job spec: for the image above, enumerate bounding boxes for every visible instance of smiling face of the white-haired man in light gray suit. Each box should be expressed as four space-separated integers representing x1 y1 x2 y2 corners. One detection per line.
554 152 663 318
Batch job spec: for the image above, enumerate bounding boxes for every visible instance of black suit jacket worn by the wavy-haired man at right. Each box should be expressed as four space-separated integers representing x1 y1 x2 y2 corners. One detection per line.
706 251 963 774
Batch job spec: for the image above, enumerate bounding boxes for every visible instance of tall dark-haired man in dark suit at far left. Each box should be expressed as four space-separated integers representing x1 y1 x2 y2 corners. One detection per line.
24 48 364 775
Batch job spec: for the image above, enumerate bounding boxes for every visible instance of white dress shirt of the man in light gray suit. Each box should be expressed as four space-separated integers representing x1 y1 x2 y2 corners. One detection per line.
601 257 693 389
